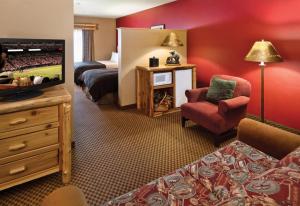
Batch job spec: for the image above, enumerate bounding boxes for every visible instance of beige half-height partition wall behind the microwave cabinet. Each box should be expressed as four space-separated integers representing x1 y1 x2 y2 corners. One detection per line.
118 28 187 106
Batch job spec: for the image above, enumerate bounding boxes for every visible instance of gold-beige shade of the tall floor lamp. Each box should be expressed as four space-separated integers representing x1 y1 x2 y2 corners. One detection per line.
245 40 282 62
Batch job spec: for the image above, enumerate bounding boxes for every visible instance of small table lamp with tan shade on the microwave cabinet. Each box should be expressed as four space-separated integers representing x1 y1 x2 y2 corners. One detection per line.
161 32 183 65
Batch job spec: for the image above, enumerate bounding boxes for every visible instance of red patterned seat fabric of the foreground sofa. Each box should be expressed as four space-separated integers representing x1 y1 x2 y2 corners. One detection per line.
105 141 300 206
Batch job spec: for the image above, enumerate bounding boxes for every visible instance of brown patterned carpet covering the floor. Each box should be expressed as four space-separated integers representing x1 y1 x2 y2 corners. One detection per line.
0 89 232 206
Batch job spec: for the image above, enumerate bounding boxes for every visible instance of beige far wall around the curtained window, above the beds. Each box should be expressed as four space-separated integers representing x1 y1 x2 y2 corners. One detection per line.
74 16 116 60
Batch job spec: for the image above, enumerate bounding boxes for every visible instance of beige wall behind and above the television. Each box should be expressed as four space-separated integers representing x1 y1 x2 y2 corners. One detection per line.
0 0 74 94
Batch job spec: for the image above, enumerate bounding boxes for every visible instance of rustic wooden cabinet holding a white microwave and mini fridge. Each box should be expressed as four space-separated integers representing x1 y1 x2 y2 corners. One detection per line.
136 64 196 117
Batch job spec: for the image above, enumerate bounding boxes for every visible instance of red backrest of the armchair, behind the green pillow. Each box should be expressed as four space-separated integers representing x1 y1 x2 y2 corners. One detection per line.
211 75 251 97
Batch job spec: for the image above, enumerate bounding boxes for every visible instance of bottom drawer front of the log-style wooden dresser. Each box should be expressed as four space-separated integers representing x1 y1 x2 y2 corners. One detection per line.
0 150 58 184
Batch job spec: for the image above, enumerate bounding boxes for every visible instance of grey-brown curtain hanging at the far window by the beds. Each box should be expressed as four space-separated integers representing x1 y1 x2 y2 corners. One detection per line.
82 30 94 61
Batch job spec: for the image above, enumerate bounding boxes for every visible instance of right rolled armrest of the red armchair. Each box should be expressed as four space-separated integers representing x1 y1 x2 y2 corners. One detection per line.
218 96 250 115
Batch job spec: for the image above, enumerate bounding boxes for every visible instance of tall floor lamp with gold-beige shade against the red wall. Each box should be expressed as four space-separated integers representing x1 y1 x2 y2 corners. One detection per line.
245 40 282 122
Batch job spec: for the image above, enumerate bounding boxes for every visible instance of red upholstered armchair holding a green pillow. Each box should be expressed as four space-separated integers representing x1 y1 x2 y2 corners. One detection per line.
181 75 251 146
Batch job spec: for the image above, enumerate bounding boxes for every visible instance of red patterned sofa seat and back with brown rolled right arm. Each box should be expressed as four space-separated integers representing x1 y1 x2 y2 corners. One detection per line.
105 119 300 206
